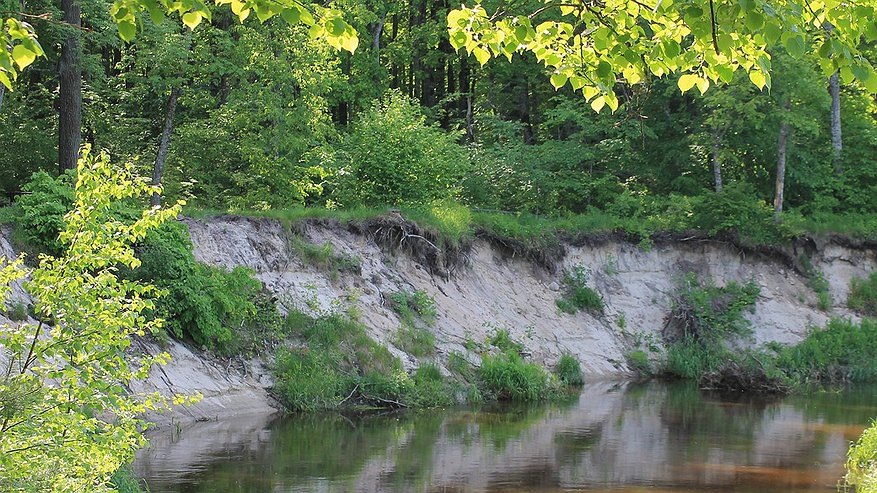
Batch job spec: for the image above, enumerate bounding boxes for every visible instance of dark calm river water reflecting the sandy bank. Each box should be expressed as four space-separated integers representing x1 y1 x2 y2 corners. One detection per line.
135 383 877 493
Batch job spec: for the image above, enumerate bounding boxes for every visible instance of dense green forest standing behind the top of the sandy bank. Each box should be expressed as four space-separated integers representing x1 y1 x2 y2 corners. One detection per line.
0 1 877 242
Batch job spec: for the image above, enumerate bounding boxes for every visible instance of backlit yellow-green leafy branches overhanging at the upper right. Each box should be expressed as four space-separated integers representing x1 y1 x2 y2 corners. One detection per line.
448 0 877 111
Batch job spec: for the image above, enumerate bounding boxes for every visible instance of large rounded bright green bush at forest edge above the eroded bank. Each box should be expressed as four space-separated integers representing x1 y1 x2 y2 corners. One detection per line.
329 93 468 207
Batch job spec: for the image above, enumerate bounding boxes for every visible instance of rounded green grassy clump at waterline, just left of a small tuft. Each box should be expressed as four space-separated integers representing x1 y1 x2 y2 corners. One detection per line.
478 353 552 401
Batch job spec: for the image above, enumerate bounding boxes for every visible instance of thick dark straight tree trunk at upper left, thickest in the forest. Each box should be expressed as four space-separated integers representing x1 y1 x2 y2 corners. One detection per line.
58 0 82 173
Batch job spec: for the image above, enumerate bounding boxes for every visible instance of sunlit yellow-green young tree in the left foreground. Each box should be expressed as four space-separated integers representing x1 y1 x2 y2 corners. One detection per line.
0 147 197 492
